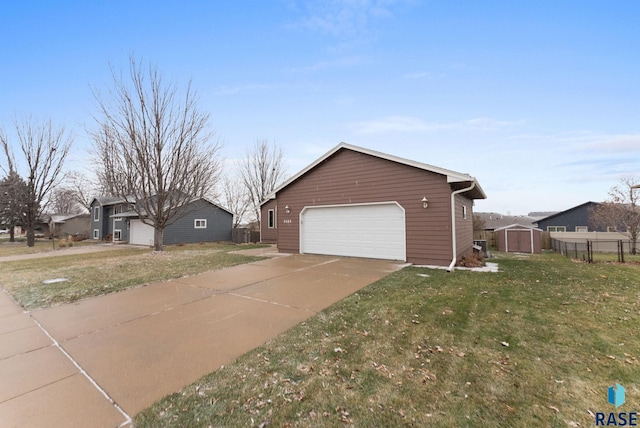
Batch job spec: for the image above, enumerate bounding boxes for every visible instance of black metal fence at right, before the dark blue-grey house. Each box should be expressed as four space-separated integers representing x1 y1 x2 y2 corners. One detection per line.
551 238 640 263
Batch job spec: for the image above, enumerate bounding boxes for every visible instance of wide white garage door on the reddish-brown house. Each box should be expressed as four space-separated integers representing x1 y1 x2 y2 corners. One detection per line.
300 202 406 260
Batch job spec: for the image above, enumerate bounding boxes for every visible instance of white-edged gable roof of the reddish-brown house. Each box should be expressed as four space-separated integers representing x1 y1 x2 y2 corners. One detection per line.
261 143 487 205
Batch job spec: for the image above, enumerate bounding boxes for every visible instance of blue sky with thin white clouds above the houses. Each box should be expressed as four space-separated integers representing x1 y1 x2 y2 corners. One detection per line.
0 0 640 214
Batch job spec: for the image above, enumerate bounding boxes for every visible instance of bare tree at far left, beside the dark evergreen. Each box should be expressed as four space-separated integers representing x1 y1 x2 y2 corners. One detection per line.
0 118 72 247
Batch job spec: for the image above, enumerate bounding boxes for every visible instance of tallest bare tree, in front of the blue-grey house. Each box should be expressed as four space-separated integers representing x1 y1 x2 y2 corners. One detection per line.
92 58 221 251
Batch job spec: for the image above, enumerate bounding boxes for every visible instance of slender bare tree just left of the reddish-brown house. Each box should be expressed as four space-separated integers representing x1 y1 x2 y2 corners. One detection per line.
238 139 286 221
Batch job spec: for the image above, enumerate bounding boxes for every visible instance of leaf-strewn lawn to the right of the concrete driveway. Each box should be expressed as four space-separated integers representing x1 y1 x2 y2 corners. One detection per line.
135 254 640 427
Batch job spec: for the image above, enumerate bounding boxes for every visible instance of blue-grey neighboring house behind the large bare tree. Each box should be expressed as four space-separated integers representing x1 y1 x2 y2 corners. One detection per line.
91 198 233 245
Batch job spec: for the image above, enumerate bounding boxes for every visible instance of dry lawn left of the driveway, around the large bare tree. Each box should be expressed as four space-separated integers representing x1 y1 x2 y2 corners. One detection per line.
0 244 268 310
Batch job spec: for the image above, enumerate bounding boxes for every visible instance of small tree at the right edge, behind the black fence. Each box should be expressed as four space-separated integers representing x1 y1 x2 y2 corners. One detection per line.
590 177 640 254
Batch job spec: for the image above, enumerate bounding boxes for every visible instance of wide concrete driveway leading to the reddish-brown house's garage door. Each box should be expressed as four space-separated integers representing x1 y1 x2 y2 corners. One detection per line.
0 255 402 427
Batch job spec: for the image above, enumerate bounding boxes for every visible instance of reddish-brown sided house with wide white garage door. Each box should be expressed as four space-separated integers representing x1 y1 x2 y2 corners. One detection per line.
260 143 486 269
